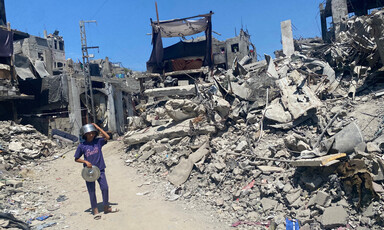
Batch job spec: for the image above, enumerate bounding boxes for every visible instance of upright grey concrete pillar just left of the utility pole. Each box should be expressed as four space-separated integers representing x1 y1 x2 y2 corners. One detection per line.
67 76 83 137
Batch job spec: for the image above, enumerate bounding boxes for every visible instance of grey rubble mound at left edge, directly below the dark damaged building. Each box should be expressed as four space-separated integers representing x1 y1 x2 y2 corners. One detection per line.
0 121 56 170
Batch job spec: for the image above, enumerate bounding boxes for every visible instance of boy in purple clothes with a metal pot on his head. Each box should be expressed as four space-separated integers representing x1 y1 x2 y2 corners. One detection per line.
75 123 118 220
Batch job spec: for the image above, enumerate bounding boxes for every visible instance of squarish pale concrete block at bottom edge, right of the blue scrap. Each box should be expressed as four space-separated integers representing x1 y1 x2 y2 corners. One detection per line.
320 206 348 228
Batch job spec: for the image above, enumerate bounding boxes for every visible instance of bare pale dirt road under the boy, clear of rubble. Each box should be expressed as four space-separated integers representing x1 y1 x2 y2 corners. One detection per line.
32 141 228 230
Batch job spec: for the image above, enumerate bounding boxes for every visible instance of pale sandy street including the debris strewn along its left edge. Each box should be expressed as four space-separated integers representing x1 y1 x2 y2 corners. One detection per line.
0 142 228 230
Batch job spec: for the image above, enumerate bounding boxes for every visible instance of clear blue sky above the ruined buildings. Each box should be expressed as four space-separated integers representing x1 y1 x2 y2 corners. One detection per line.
5 0 324 71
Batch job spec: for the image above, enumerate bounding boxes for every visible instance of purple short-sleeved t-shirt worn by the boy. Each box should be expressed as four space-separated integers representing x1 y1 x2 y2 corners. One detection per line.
75 138 107 170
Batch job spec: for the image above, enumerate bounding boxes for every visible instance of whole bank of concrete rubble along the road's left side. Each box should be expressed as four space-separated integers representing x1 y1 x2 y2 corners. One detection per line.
0 121 73 229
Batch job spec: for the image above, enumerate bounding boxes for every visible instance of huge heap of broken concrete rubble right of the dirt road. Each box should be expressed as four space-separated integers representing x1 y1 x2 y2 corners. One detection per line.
124 11 384 229
